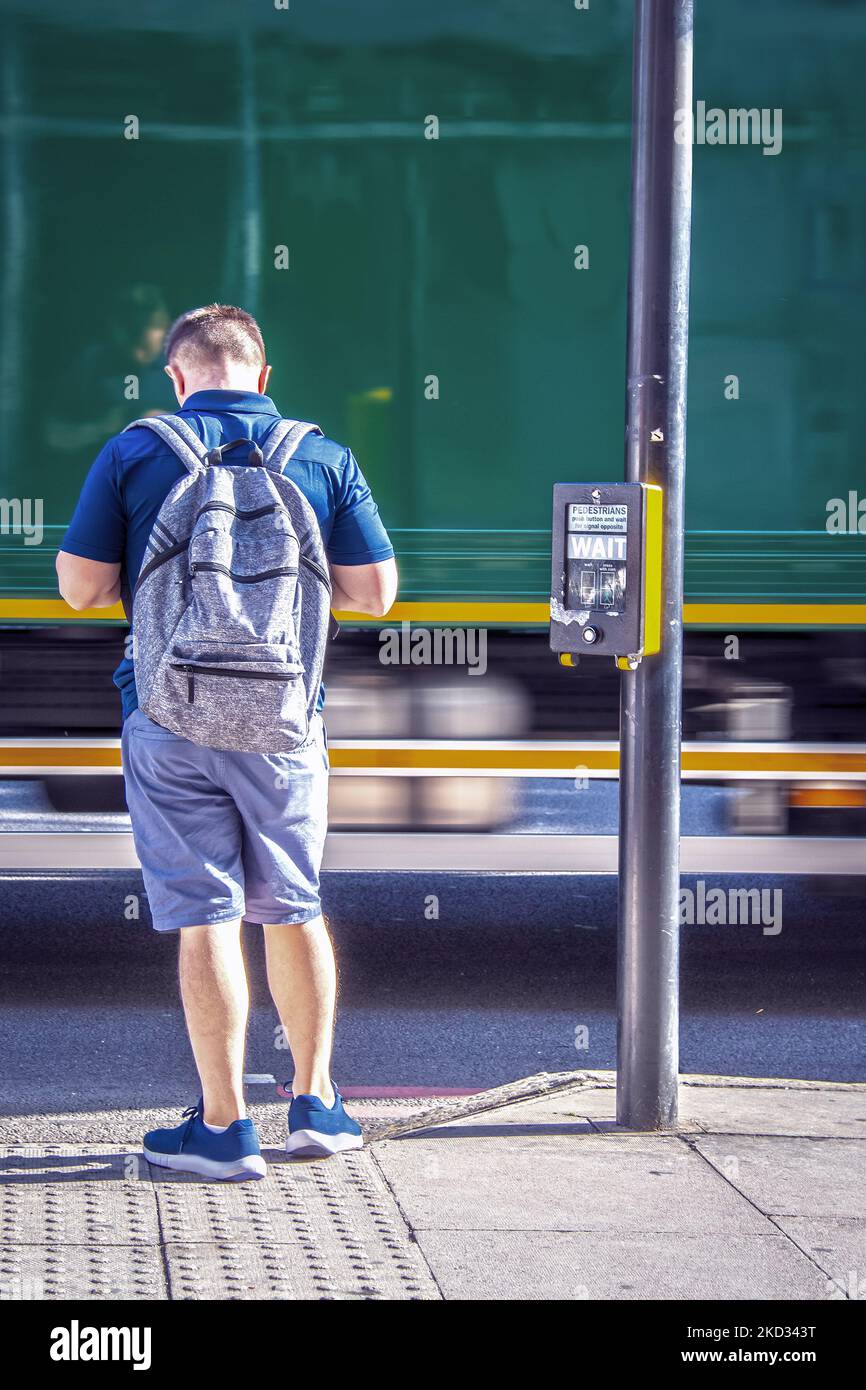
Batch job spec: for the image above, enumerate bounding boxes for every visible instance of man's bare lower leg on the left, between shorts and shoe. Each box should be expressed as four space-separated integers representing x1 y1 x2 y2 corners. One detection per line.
181 919 250 1125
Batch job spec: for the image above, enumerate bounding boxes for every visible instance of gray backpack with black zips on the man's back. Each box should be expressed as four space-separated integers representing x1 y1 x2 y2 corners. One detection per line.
126 416 331 753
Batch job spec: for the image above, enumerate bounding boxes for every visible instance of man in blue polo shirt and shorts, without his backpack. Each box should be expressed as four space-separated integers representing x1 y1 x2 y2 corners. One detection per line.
57 304 396 1177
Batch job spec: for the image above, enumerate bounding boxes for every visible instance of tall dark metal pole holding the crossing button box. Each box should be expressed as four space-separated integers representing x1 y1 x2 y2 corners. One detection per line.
617 0 692 1130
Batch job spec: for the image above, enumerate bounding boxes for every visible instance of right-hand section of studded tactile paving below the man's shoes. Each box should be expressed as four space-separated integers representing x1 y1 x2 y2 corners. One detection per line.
154 1151 441 1301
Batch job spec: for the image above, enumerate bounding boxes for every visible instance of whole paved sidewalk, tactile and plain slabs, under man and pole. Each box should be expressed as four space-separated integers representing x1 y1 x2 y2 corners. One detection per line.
0 1072 866 1300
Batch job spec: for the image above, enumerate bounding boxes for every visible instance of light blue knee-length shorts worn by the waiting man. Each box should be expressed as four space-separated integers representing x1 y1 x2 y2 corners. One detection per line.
121 709 328 931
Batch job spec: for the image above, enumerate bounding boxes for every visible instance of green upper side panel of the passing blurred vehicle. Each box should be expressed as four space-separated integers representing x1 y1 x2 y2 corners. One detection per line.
0 0 866 750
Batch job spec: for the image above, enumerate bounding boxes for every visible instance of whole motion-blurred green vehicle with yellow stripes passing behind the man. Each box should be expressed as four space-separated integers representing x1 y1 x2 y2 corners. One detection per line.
0 0 866 872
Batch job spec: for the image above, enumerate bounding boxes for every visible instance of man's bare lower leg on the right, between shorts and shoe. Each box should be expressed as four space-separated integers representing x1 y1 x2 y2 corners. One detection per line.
264 916 336 1105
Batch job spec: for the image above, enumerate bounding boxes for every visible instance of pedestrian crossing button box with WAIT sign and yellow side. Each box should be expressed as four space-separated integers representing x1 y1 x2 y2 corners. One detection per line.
550 482 662 669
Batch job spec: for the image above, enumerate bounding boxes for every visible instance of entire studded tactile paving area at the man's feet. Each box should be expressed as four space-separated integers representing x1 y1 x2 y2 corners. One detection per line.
0 1144 441 1301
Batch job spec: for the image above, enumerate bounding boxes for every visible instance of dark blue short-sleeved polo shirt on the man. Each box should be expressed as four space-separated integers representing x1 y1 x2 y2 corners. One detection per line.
60 391 393 719
